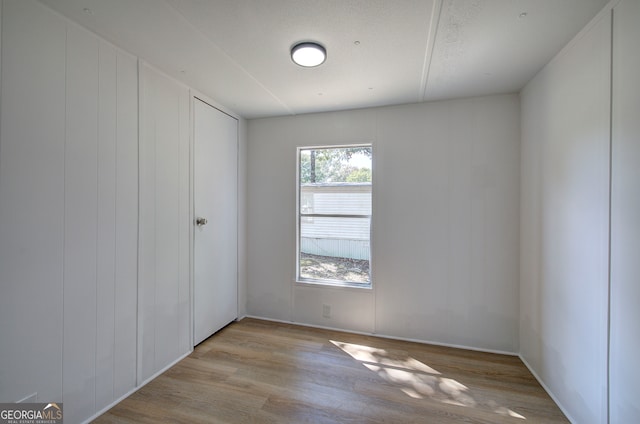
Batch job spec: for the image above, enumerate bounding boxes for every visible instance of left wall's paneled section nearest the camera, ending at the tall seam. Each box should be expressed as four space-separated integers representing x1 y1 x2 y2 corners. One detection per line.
0 1 138 422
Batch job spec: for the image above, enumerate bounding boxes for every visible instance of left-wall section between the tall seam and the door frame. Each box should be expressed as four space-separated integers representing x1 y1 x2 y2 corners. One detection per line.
138 64 192 380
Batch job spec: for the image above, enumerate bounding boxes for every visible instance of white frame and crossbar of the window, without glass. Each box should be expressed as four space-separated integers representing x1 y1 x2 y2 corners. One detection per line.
295 143 373 290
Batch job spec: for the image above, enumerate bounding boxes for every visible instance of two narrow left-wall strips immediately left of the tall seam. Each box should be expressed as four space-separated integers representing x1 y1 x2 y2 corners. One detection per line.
96 42 138 409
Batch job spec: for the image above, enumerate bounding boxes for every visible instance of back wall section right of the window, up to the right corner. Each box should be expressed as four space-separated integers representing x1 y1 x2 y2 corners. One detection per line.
373 95 520 352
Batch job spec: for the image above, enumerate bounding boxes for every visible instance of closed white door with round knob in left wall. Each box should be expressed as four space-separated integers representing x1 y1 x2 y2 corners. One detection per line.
194 99 238 344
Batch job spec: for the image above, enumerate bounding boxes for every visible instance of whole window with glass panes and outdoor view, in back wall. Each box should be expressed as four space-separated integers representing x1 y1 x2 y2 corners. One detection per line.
297 145 373 287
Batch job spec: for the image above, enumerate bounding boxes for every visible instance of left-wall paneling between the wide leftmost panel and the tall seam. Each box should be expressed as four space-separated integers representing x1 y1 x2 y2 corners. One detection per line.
63 25 138 419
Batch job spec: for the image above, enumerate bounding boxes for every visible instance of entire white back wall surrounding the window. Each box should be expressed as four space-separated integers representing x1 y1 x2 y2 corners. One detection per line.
247 95 520 352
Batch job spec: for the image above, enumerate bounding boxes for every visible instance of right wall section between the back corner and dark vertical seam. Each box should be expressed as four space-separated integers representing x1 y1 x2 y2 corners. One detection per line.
520 6 611 424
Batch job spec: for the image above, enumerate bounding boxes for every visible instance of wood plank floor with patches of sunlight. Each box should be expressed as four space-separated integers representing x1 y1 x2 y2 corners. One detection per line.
95 318 568 424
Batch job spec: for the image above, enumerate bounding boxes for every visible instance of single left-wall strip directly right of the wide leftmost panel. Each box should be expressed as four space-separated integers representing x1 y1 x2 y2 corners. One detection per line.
63 25 99 422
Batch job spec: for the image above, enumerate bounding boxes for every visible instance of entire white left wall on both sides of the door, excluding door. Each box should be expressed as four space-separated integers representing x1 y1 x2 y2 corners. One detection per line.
0 0 247 422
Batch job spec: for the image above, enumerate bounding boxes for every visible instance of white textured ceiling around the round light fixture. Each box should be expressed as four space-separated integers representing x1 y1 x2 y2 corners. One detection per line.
41 0 607 118
